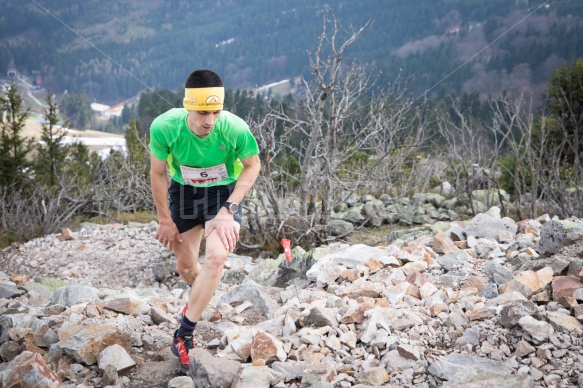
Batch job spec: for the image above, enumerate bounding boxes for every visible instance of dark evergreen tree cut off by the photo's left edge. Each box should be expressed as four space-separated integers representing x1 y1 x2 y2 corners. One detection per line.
0 83 33 187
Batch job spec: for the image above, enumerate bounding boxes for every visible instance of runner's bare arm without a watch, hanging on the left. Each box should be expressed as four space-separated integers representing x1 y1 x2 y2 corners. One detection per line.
150 154 182 249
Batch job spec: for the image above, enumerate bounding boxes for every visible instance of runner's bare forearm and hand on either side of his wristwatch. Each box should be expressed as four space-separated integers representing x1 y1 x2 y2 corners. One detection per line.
205 155 261 251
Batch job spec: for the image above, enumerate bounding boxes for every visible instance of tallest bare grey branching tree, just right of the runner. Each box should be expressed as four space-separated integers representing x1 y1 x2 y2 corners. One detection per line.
246 13 425 249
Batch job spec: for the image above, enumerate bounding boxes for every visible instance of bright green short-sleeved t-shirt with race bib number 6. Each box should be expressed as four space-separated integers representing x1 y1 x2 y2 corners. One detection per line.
150 108 259 187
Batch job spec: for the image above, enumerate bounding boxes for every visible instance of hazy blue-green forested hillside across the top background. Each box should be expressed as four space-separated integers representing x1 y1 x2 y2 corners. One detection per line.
0 0 583 103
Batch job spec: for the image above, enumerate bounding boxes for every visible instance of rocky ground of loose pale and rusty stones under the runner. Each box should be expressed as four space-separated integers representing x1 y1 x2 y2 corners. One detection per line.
0 207 583 388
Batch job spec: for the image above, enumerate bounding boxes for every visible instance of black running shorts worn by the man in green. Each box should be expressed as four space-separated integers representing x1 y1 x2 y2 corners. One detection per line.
168 180 243 233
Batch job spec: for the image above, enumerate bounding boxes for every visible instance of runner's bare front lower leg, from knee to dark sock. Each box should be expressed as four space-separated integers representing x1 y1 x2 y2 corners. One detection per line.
183 231 229 322
